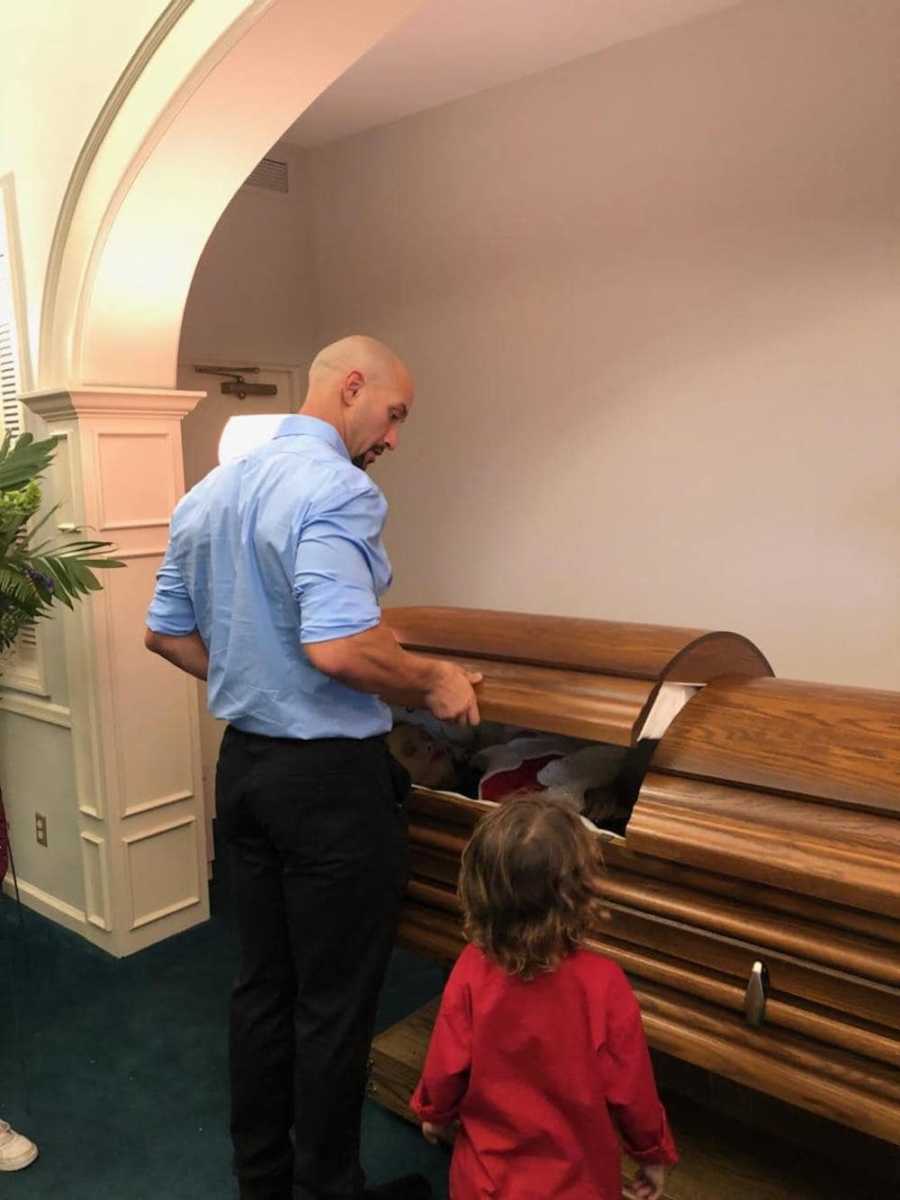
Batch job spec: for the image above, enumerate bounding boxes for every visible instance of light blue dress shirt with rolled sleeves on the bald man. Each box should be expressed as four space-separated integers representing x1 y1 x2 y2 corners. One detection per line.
146 415 391 738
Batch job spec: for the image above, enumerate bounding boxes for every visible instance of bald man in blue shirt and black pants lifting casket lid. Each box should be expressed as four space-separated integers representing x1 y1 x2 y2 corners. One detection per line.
145 336 480 1200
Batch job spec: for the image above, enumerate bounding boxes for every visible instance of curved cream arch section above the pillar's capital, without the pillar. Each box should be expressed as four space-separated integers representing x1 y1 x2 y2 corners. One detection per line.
37 0 421 390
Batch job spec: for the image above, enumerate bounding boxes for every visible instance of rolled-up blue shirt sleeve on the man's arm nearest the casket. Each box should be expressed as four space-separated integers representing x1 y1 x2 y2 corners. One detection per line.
294 480 390 643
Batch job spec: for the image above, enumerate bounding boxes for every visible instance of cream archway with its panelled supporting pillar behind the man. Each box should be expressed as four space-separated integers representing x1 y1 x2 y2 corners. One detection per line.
15 0 418 955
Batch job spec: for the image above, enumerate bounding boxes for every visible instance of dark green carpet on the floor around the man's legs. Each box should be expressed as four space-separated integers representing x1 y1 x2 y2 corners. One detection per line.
0 884 448 1200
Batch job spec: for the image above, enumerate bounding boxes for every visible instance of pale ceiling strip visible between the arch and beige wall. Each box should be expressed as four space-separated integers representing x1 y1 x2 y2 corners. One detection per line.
284 0 743 146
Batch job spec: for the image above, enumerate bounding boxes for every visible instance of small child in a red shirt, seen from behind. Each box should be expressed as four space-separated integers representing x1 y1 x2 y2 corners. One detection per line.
410 796 678 1200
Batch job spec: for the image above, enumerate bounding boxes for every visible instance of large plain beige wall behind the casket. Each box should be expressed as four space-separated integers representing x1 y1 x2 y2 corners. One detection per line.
300 0 900 688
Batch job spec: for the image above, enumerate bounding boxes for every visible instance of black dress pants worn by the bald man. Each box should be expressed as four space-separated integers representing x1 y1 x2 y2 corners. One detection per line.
216 726 409 1200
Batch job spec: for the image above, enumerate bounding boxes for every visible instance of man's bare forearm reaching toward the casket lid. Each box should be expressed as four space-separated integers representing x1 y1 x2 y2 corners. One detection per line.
304 624 445 708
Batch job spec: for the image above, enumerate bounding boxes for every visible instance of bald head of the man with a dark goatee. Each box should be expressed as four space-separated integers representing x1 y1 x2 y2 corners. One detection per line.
302 334 414 469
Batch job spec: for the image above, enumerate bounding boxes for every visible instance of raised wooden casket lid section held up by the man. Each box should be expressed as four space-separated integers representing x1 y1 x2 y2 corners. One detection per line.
384 607 772 746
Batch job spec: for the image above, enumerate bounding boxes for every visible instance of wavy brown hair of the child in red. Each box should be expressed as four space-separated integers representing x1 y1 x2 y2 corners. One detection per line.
460 793 604 979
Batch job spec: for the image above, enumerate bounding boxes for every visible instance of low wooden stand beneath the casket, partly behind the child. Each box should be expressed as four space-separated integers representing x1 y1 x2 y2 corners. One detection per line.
368 997 900 1200
